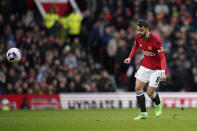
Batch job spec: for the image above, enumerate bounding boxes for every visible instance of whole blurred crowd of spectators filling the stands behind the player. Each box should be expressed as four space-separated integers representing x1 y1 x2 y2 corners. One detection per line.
0 0 197 94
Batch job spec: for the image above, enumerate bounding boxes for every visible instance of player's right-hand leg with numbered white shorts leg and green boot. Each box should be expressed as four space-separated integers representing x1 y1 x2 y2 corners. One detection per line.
147 70 162 116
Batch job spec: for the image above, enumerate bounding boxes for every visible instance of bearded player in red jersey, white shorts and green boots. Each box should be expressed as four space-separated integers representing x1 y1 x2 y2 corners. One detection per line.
124 20 167 120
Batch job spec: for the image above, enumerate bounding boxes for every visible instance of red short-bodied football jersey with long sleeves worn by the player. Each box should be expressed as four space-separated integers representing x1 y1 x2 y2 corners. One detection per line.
129 33 166 70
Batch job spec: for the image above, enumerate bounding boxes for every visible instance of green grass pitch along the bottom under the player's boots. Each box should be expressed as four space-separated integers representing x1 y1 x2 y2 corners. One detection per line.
0 108 197 131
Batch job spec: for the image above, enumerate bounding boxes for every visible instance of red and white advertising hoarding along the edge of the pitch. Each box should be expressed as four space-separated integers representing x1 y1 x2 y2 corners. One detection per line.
0 92 197 109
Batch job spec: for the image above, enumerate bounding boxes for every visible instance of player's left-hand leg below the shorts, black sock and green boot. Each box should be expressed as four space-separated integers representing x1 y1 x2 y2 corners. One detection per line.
134 79 148 120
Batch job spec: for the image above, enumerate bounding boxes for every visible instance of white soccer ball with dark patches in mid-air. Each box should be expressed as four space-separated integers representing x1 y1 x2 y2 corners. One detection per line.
6 48 22 63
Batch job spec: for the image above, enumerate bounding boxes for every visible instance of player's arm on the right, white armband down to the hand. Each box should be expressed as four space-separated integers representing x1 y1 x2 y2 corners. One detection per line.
157 46 167 81
